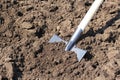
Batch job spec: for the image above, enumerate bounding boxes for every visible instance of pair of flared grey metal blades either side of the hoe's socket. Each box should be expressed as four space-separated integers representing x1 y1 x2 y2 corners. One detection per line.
49 34 87 61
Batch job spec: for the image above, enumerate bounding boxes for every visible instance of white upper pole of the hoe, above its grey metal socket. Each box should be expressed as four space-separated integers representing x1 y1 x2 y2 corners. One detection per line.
78 0 104 31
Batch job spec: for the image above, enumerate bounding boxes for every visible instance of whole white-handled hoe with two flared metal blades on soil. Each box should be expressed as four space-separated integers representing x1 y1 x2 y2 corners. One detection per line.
49 0 103 61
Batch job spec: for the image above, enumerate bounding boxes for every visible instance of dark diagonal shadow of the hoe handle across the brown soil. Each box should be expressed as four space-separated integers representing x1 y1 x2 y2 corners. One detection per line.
78 10 120 41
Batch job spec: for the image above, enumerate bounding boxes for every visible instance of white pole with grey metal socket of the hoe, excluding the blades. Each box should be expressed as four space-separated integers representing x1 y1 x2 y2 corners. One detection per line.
65 0 104 51
